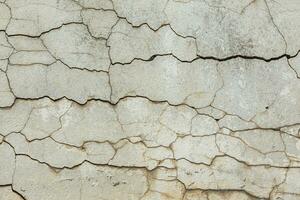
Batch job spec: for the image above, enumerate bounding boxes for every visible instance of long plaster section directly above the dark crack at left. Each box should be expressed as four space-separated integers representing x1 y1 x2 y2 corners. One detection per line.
7 62 110 104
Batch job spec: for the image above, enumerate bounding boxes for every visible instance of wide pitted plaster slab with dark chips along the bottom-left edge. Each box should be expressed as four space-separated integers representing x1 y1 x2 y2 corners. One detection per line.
13 156 148 200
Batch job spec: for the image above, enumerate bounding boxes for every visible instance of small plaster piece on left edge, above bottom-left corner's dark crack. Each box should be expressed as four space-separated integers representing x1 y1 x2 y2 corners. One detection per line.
0 142 15 184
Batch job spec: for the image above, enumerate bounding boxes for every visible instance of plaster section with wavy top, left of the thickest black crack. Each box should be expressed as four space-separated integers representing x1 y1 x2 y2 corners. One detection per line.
108 20 197 63
